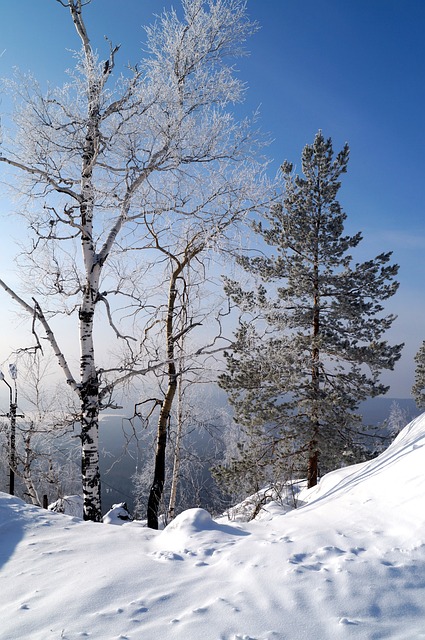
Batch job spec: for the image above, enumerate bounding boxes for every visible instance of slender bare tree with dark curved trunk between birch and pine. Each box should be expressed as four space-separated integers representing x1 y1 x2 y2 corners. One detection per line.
138 186 261 529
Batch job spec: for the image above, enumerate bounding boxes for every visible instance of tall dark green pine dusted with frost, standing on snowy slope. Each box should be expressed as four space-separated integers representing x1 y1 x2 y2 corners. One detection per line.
220 131 403 487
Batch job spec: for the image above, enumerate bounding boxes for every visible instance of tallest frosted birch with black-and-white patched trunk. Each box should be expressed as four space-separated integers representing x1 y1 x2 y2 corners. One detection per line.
0 0 260 521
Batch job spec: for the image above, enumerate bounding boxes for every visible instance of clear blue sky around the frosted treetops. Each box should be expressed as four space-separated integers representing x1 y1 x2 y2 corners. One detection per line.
0 0 425 397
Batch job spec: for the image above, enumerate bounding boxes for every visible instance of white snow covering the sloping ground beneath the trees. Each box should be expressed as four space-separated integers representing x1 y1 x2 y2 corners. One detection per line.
0 414 425 640
